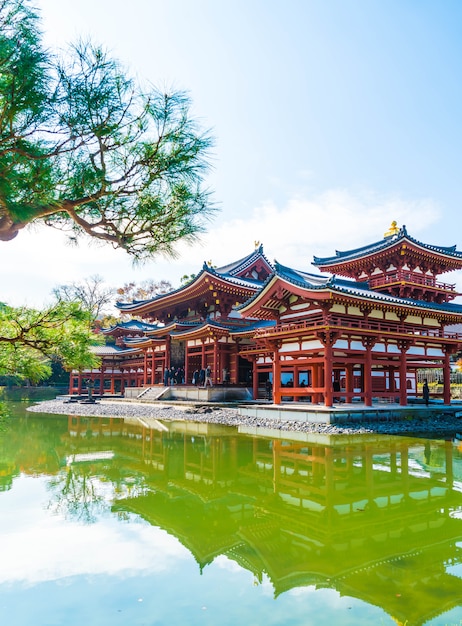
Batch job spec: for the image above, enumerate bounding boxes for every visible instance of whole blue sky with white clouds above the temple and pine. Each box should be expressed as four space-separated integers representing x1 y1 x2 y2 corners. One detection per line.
0 0 462 312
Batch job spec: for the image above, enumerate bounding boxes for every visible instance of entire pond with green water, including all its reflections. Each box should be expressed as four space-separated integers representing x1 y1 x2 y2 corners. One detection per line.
0 392 462 626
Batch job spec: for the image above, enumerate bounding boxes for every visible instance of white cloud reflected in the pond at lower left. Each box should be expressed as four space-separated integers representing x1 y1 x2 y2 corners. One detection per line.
0 508 190 584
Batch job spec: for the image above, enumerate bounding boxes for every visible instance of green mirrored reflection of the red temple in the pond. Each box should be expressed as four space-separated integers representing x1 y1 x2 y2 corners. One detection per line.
60 417 462 625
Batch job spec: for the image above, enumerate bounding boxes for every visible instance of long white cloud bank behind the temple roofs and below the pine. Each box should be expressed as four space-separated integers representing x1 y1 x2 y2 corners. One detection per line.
0 190 442 306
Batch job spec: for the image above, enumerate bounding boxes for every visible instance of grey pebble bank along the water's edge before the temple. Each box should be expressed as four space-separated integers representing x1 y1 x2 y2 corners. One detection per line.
28 398 462 437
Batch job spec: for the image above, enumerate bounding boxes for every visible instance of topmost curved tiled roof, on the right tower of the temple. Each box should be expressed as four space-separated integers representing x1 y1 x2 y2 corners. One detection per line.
313 226 462 267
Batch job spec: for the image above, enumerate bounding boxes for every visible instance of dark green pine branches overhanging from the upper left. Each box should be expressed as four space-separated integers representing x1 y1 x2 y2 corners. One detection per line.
0 0 214 260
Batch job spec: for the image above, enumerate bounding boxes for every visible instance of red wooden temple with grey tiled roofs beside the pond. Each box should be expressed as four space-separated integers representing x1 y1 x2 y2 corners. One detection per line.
70 222 462 407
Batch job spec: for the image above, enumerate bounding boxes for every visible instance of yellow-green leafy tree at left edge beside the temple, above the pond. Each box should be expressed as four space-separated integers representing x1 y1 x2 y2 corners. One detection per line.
0 301 99 383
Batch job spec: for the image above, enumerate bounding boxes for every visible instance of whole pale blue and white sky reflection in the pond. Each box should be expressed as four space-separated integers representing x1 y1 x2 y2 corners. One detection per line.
0 477 392 626
